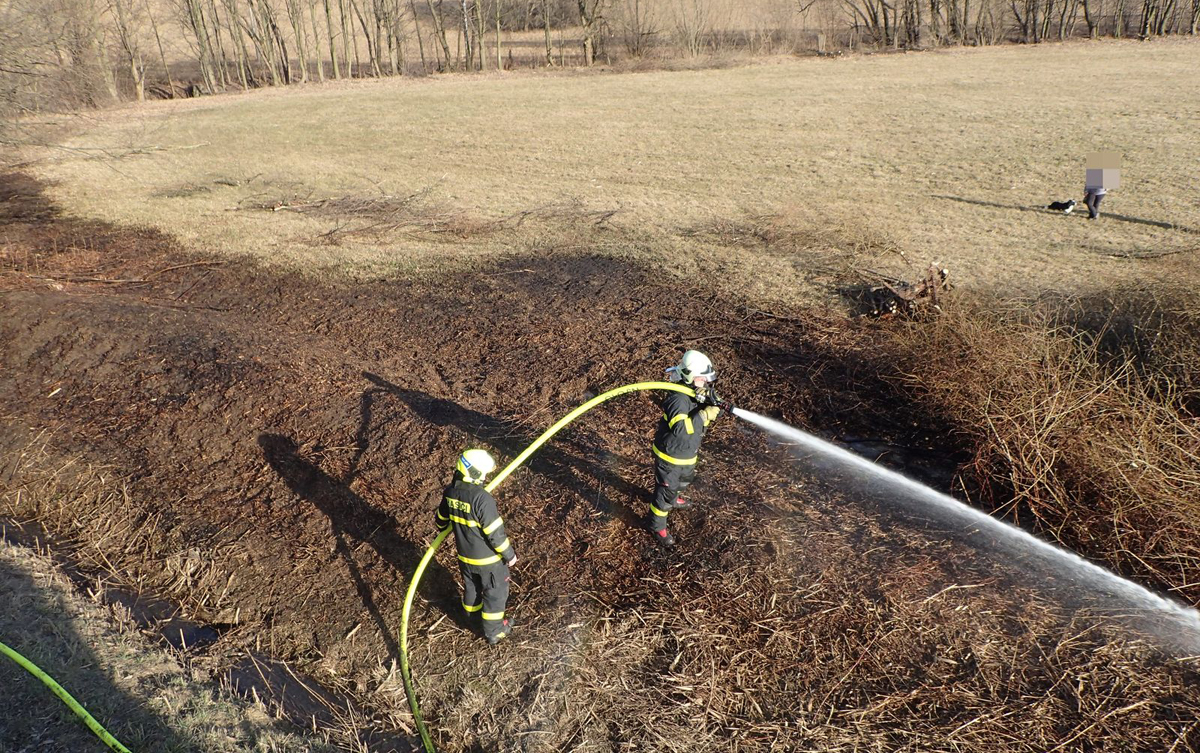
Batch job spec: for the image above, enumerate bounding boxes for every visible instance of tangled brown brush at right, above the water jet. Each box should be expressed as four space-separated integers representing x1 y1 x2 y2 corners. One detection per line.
893 290 1200 604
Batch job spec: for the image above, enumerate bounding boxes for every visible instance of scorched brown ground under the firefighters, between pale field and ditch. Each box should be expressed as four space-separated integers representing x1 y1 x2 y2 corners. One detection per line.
0 175 1200 751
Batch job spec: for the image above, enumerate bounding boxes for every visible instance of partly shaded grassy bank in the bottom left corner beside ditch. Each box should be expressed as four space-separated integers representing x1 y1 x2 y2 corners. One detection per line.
0 527 332 753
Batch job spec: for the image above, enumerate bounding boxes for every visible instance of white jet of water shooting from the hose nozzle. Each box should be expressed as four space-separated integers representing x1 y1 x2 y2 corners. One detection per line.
733 408 1200 647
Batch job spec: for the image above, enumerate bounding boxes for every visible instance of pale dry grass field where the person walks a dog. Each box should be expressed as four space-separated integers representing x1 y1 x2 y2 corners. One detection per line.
42 40 1200 301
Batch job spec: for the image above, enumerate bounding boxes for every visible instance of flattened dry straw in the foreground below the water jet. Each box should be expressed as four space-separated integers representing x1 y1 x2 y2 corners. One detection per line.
398 462 1200 753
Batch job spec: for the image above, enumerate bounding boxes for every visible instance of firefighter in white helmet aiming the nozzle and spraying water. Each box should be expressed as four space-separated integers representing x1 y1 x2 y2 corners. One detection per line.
646 350 721 547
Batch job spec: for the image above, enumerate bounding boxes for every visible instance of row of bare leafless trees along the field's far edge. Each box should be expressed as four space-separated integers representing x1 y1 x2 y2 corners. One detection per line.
0 0 1200 114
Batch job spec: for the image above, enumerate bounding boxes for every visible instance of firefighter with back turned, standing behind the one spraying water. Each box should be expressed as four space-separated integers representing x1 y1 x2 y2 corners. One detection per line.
437 450 517 646
